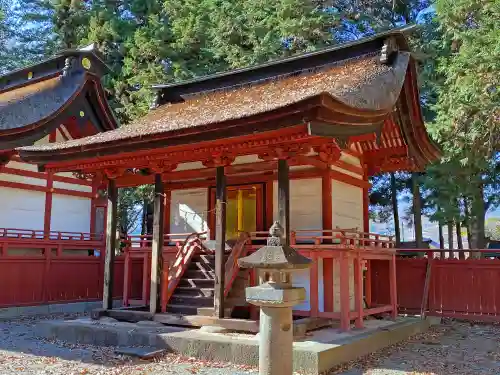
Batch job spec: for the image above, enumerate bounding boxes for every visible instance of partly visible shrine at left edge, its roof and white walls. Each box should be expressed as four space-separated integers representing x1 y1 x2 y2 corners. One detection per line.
0 48 117 238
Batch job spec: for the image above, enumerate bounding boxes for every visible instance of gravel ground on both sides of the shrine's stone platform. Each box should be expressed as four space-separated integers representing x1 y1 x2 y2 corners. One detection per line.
0 316 500 375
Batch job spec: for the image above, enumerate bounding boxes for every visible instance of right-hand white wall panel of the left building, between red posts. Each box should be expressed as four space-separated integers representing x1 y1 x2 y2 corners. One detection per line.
51 194 91 233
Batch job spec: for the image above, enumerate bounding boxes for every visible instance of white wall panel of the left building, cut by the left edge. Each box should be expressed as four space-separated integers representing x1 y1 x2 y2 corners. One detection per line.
0 187 45 230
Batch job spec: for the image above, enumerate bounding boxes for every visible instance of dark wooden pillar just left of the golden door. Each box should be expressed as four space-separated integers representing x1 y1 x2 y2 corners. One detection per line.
214 166 226 319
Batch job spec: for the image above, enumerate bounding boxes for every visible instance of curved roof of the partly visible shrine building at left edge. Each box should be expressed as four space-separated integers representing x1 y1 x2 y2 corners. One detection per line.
0 50 116 150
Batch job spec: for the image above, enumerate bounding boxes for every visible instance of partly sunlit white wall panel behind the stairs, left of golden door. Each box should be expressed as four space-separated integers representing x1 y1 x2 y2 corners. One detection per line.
170 188 208 233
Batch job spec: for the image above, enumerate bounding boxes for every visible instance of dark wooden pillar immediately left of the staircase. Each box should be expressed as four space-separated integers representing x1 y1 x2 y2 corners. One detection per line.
149 173 165 314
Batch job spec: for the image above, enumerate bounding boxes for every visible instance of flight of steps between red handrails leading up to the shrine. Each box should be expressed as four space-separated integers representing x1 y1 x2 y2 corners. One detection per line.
167 252 248 317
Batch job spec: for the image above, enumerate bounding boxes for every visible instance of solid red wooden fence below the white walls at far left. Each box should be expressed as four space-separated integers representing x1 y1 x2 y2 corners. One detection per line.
0 228 108 307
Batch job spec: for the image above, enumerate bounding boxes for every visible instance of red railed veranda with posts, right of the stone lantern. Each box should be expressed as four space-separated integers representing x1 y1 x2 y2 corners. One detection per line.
240 229 397 330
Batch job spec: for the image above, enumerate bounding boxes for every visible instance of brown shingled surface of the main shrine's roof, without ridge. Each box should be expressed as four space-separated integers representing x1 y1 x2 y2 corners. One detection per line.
19 52 410 151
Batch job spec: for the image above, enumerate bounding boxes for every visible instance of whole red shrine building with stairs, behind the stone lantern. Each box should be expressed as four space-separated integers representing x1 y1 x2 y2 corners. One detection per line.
10 30 439 330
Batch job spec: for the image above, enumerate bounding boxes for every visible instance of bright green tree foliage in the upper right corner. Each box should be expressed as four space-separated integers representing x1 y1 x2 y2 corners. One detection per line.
432 0 500 160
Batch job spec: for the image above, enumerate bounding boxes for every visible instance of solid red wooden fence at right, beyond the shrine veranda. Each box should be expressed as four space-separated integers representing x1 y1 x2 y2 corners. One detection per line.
371 250 500 321
